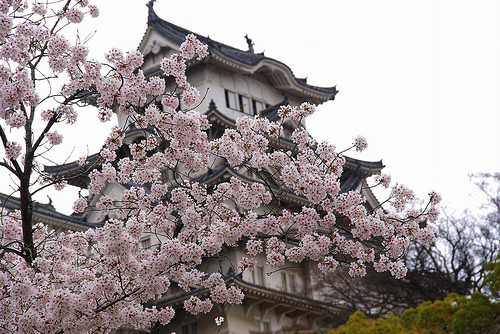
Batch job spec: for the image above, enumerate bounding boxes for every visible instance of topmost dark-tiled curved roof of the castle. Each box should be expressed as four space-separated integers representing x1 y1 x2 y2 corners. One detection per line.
141 1 338 102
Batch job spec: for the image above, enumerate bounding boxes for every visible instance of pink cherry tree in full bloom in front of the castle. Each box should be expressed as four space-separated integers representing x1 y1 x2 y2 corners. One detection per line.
0 0 440 333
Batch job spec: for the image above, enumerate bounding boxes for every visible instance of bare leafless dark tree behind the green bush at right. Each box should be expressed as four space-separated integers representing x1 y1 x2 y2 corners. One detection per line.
318 173 500 318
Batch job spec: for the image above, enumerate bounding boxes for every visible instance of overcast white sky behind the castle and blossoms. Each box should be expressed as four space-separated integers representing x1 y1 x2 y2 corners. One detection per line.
24 0 500 214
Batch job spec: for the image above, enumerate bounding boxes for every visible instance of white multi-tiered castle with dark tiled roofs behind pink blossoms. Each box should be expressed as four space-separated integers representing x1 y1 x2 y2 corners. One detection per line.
40 1 383 334
